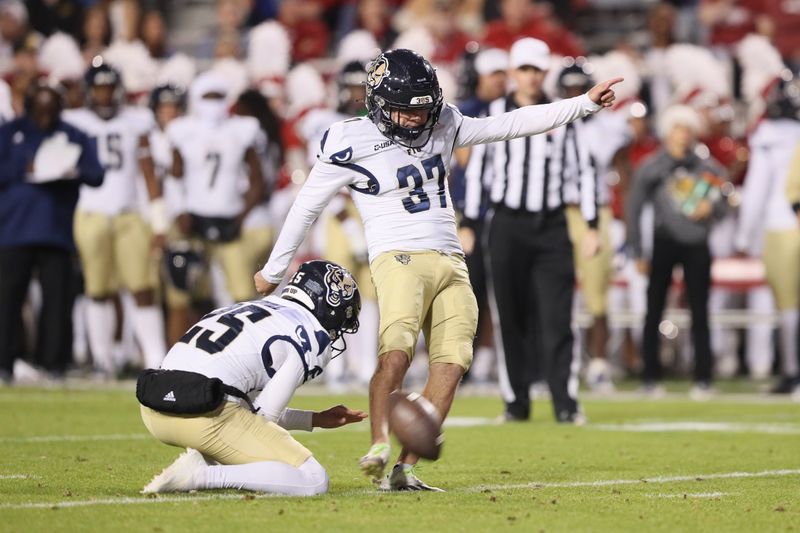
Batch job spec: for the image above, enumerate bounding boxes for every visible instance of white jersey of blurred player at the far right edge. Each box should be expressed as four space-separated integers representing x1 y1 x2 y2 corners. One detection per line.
736 119 800 254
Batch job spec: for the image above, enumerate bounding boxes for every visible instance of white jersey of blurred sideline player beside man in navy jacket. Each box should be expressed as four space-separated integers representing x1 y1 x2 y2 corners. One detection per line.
63 107 155 215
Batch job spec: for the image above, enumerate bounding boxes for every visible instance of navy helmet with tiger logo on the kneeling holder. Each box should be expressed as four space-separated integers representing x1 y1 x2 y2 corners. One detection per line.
281 260 361 341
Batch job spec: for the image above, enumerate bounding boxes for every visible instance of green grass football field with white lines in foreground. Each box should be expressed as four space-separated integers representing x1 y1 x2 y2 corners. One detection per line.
0 382 800 533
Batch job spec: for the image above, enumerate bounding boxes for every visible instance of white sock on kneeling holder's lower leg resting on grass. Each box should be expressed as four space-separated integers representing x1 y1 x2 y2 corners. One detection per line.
204 457 328 496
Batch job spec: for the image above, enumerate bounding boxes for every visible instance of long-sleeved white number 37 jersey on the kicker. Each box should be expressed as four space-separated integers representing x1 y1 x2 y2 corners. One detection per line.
261 94 600 283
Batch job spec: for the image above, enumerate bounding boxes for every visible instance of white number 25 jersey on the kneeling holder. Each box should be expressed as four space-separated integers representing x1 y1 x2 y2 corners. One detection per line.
161 296 331 429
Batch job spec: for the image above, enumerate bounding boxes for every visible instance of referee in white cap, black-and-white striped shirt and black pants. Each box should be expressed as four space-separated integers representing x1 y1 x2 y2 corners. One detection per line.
462 38 599 424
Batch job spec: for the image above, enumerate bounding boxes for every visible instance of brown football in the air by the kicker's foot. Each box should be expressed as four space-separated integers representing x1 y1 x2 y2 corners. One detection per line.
389 390 444 461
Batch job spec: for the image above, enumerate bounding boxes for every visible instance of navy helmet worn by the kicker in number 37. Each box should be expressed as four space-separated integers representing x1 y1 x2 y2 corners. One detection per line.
367 48 443 148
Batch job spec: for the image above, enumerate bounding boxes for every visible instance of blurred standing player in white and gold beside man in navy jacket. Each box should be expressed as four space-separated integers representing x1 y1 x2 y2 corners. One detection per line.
64 63 167 375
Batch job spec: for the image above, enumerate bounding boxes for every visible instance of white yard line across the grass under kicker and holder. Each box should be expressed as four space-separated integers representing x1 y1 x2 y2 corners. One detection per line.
0 469 800 509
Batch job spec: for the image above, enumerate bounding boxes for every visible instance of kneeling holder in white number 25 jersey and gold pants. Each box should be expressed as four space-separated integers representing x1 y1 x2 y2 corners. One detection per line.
142 261 367 496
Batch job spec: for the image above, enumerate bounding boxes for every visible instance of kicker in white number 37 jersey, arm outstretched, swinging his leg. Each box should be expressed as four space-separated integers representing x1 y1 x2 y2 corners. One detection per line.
255 49 622 490
